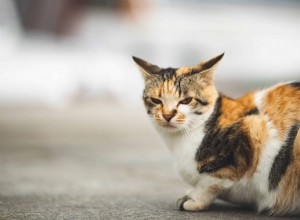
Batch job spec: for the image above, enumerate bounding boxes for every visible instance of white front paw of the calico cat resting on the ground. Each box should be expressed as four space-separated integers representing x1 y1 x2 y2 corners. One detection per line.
176 185 220 212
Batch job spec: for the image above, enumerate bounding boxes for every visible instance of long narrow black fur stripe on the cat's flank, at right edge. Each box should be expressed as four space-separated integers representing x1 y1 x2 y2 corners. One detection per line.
269 123 300 190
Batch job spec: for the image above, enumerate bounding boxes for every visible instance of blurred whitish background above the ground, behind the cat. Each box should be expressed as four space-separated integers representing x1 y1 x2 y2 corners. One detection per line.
0 0 300 105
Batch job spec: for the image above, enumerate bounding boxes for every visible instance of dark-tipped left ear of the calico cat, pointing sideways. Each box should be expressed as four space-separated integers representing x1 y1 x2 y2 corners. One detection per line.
132 56 162 82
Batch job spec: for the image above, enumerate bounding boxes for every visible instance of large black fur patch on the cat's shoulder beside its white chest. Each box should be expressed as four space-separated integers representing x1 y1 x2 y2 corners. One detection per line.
195 96 252 173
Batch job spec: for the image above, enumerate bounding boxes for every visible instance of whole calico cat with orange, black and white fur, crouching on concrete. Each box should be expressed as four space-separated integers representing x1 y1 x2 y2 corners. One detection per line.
133 54 300 215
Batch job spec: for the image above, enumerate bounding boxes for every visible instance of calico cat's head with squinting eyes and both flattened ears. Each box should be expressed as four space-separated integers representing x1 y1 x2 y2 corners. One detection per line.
133 53 224 132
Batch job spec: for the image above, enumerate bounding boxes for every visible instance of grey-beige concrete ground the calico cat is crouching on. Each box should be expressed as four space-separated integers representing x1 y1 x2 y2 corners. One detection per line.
0 103 299 220
